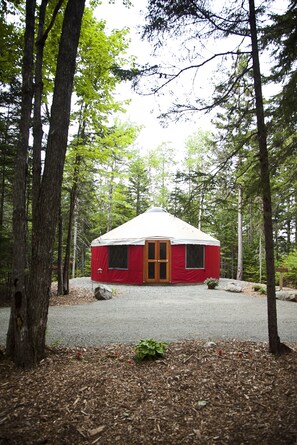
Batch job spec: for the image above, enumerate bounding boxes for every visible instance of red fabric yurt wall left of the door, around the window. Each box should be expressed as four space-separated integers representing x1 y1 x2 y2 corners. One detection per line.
91 246 143 284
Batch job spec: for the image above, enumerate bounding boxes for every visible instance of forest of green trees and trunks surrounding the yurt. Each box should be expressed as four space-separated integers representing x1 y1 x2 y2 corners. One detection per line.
0 0 297 361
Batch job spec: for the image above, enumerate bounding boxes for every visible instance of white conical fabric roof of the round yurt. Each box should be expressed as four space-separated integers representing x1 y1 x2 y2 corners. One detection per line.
92 207 220 247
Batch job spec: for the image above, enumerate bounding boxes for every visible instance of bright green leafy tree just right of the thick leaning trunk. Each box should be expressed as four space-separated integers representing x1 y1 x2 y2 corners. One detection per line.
58 9 131 294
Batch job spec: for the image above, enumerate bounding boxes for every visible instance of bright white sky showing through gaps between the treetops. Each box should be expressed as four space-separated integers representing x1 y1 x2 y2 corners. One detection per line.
97 0 287 153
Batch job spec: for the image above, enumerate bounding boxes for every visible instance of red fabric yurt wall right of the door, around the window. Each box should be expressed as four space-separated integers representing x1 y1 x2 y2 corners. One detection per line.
171 244 220 283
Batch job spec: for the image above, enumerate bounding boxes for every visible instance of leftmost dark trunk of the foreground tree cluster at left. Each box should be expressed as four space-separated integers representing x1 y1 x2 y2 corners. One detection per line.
6 0 36 366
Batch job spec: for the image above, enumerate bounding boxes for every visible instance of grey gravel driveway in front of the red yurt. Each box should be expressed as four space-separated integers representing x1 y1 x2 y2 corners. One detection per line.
0 278 297 347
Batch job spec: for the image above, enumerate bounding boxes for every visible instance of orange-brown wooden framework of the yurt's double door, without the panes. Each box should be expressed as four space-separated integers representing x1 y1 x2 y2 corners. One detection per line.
143 239 171 284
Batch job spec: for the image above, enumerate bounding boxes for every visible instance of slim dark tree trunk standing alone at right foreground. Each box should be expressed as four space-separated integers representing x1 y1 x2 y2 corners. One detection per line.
249 0 281 354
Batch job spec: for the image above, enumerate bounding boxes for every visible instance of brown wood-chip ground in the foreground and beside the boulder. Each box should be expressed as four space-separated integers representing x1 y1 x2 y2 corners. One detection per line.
0 289 297 445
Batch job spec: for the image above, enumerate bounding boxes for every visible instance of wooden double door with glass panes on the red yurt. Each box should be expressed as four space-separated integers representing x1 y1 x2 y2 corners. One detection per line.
143 240 171 284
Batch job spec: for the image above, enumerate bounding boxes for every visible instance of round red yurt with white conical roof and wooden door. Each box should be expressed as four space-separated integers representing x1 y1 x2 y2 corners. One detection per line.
91 207 220 284
